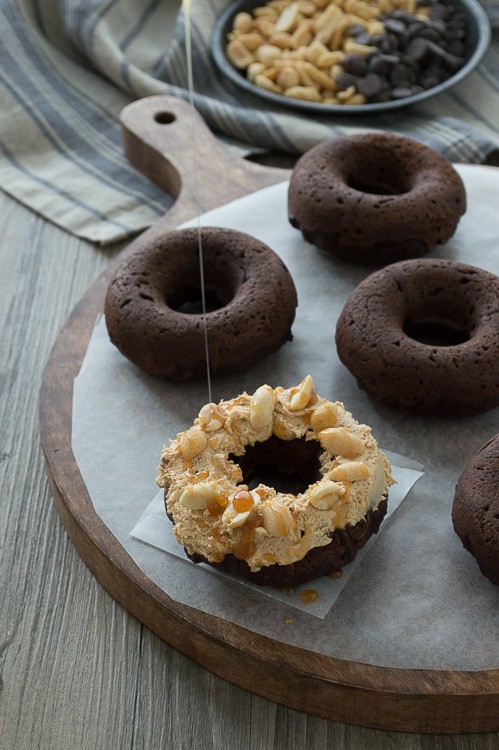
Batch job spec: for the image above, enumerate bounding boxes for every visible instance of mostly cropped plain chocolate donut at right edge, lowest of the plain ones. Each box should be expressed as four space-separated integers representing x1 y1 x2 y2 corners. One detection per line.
452 433 499 586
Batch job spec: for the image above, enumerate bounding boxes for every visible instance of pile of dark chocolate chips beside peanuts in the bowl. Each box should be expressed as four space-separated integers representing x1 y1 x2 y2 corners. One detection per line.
336 0 467 104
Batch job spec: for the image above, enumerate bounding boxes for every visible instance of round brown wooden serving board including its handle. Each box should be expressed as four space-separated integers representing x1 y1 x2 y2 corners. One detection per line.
40 96 499 733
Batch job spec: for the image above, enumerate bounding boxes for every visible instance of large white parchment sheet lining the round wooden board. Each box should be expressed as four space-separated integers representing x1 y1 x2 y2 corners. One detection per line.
73 166 499 670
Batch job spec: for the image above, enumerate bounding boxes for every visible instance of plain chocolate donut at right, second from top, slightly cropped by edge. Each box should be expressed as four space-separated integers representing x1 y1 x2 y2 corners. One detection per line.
336 259 499 415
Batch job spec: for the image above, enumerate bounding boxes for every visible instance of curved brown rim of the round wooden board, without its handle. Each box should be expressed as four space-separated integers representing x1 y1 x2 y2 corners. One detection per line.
40 269 499 733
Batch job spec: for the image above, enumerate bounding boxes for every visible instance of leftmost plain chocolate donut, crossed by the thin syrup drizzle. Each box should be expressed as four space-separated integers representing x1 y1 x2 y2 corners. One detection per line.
104 227 297 381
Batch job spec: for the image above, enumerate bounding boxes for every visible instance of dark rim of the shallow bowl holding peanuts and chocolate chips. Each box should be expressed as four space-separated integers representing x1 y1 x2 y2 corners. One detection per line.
212 0 490 115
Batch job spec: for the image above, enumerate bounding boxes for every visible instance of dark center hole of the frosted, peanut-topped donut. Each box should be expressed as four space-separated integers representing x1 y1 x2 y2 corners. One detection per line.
229 435 323 495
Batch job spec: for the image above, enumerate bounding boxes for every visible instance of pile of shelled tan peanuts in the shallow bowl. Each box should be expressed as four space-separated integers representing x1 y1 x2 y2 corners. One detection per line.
226 0 438 105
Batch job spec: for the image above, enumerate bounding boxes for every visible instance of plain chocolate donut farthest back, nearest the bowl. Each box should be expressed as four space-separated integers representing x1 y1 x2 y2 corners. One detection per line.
288 133 466 264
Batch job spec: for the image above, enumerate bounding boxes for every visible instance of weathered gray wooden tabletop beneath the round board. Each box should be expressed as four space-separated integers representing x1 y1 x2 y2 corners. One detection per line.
0 187 499 750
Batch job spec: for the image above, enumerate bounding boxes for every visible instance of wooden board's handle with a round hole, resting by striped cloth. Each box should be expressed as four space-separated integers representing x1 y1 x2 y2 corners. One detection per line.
120 95 289 229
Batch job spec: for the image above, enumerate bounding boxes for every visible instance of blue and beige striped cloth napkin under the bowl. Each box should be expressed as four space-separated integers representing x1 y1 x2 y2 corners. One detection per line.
0 0 499 244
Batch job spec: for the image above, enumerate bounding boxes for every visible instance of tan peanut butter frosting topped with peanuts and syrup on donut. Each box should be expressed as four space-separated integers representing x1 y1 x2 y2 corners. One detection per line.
156 375 393 571
